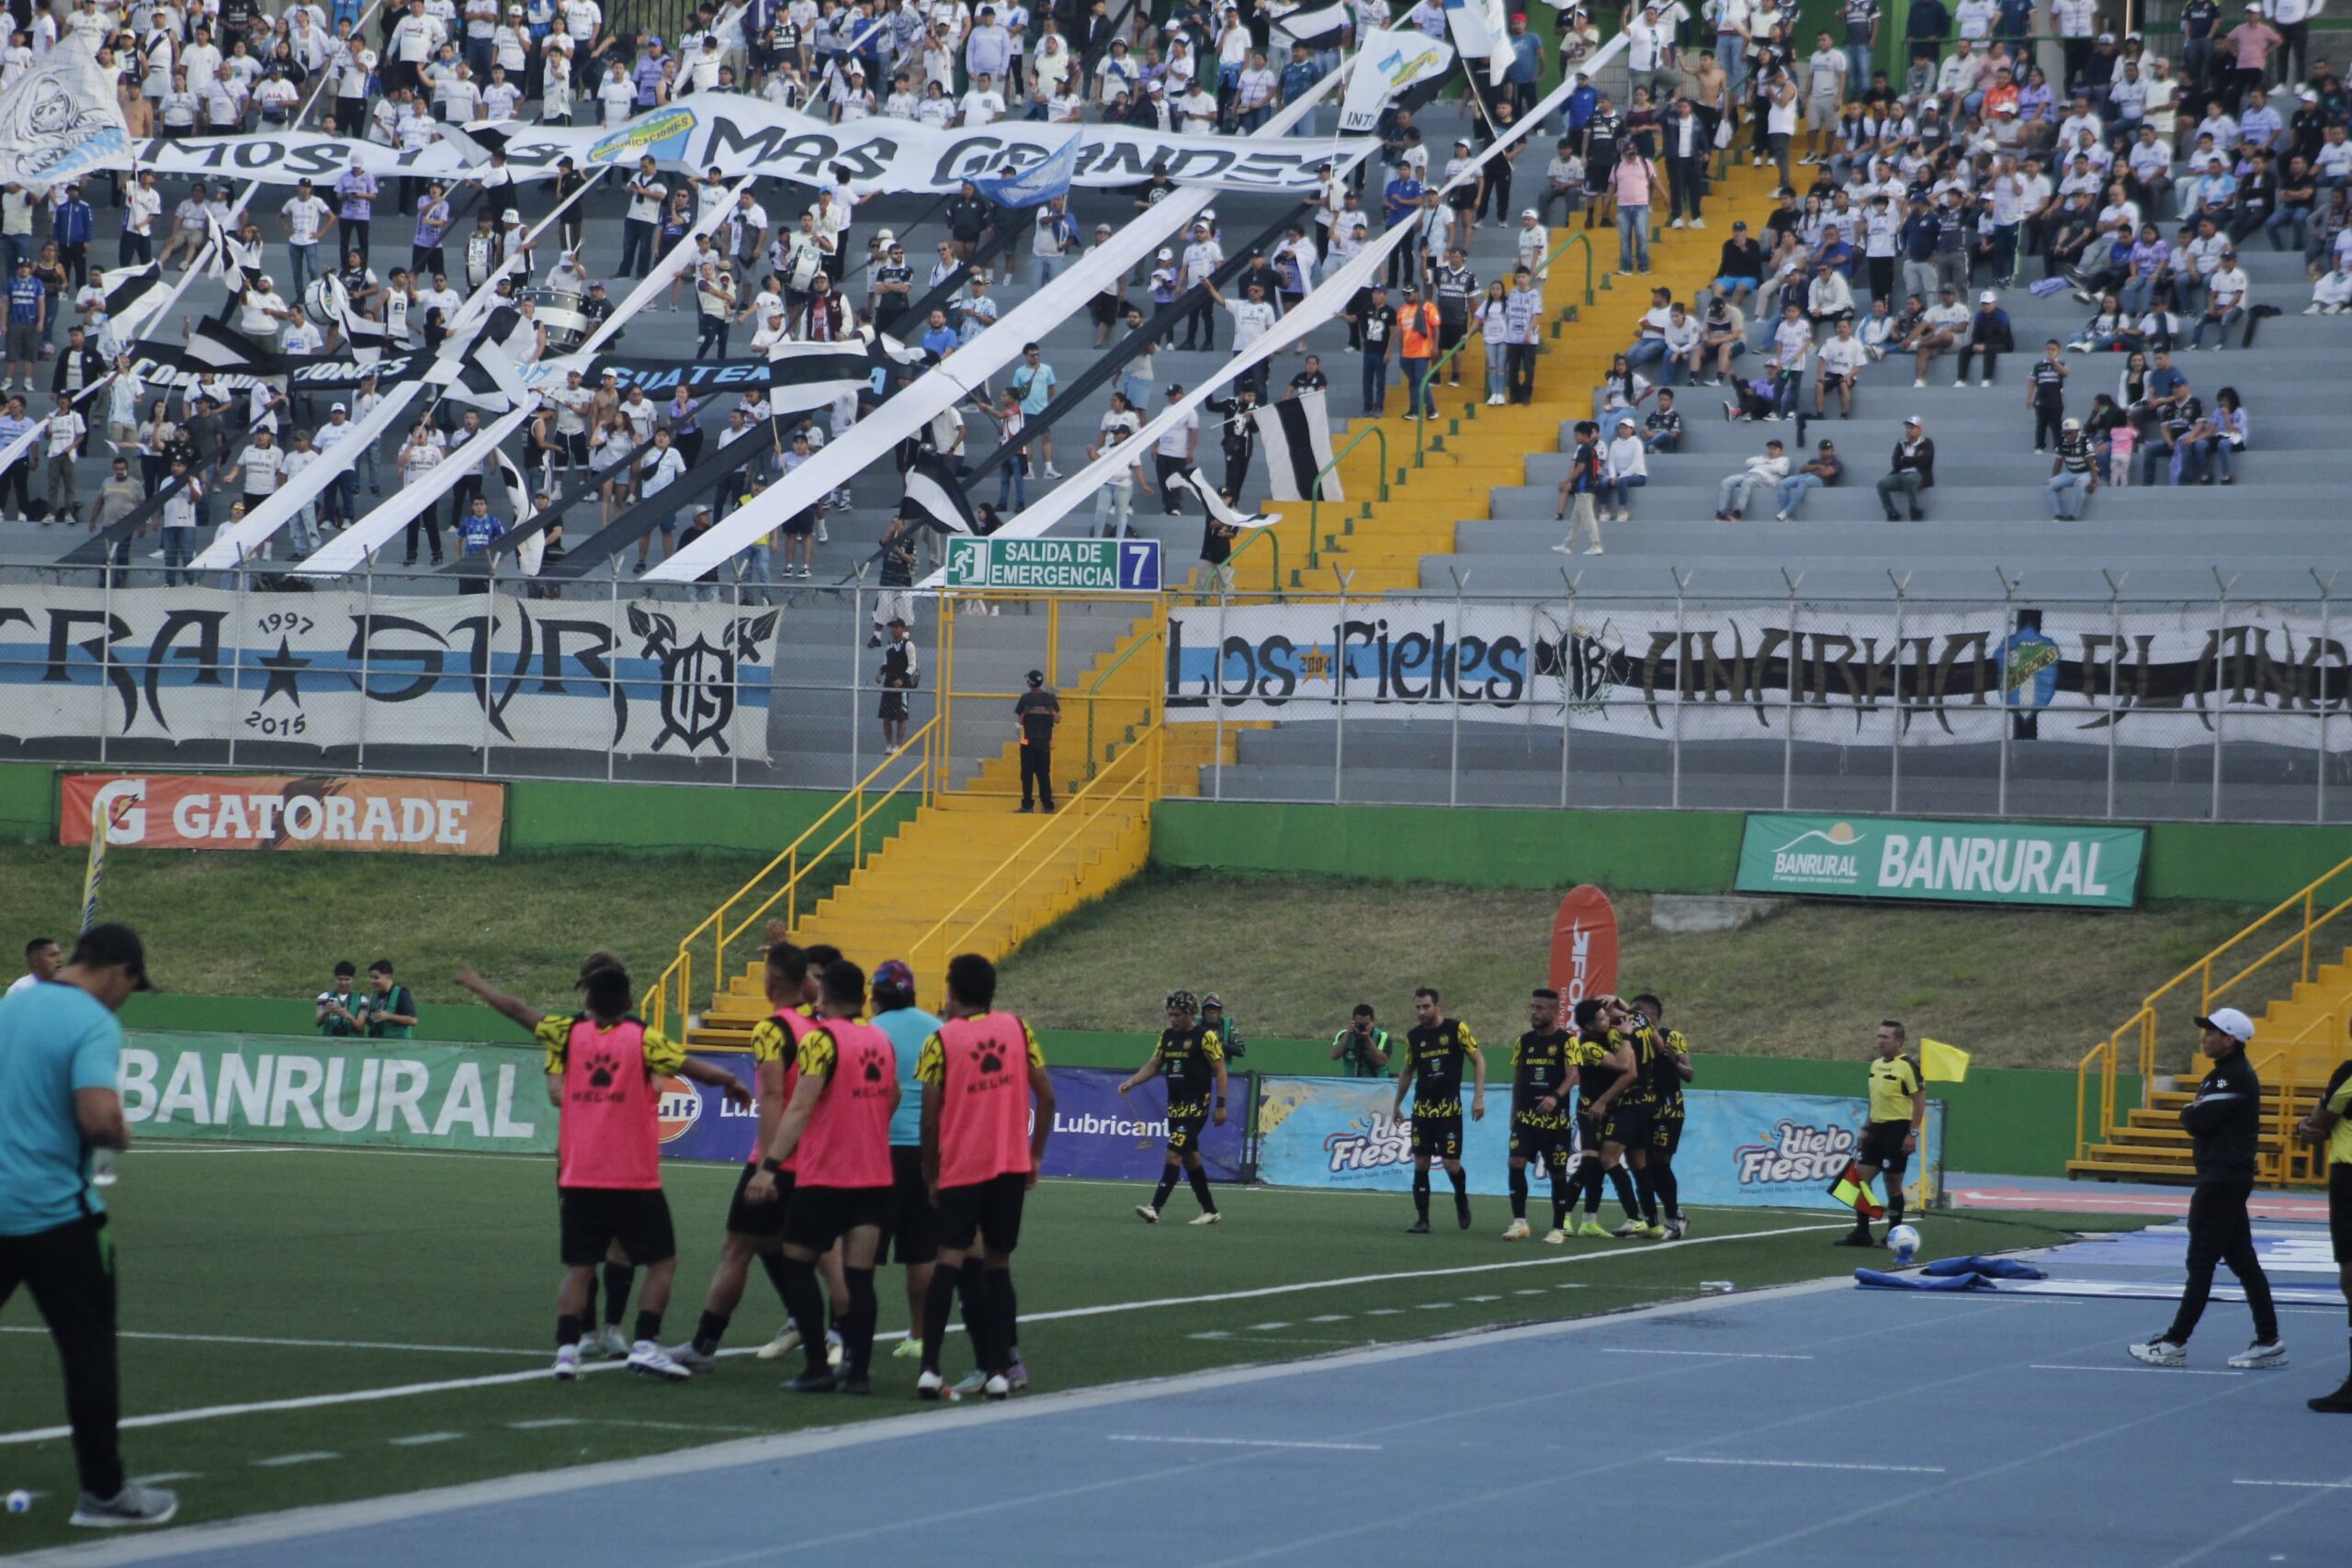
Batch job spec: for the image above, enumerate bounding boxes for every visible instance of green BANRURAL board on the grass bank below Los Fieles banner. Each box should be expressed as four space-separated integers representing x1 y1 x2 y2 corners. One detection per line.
1734 816 2147 909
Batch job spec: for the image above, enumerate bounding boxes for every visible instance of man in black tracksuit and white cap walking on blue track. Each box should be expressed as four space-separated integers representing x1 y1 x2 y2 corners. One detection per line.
2131 1006 2286 1368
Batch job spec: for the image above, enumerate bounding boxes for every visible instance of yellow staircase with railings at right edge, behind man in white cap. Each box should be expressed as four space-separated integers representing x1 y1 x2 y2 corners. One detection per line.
2067 861 2352 1185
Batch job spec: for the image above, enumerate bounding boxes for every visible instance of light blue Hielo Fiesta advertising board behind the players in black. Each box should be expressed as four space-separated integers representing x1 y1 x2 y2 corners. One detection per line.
1259 1067 1943 1211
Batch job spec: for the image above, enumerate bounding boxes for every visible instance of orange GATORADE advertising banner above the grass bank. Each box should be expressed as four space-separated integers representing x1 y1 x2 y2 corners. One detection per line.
56 773 505 856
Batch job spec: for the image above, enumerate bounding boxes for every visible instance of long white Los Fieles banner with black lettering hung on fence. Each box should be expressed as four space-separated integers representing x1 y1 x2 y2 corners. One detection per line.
1167 600 2352 752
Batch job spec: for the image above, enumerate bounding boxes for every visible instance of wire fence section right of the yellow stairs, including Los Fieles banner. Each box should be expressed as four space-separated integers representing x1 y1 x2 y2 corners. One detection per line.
1167 594 2352 823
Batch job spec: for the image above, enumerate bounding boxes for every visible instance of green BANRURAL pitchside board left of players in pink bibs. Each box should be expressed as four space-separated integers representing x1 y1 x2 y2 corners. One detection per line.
120 1030 555 1155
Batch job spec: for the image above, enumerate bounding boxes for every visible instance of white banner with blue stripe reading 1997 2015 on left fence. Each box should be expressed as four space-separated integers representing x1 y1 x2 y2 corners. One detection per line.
0 583 776 761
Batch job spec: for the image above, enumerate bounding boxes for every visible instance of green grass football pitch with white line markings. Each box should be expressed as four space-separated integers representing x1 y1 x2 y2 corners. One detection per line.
0 1145 2135 1554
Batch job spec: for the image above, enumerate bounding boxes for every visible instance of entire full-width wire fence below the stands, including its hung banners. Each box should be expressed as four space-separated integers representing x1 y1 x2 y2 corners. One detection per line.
18 569 2352 823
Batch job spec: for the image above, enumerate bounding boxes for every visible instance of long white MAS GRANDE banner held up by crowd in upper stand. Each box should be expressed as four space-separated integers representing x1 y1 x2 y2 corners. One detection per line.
139 92 1371 190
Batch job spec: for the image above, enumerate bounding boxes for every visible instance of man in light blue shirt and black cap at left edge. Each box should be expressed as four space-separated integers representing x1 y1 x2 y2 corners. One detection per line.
0 924 179 1526
